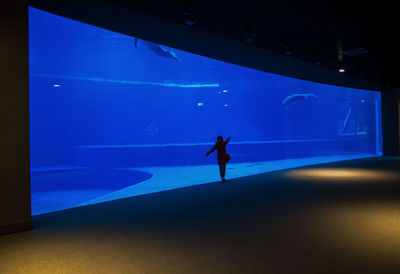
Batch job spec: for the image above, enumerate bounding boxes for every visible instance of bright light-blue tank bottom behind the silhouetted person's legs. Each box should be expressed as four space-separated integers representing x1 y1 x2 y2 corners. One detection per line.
79 154 375 206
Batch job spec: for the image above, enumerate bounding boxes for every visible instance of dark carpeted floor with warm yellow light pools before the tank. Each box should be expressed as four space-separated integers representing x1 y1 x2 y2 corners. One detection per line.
0 158 400 273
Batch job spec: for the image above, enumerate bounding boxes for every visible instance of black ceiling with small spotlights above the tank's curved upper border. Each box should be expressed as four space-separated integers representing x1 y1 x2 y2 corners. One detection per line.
110 0 400 88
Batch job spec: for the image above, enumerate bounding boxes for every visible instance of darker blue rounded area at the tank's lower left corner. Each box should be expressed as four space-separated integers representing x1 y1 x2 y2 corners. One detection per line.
31 166 152 215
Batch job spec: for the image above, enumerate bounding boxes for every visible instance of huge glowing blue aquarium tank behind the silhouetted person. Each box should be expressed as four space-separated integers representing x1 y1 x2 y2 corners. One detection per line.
29 8 382 215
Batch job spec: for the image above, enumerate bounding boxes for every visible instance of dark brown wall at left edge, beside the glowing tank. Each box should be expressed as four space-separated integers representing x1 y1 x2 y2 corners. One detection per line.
0 1 31 235
